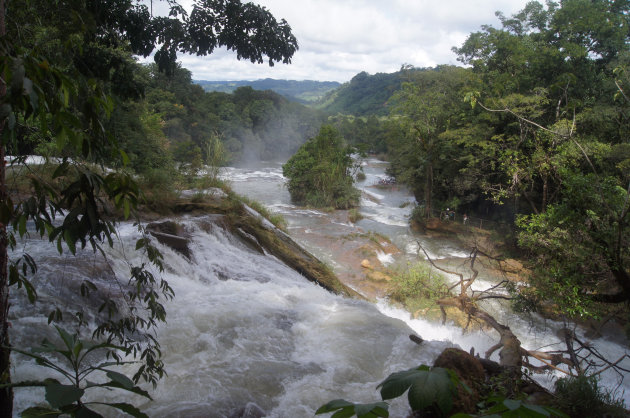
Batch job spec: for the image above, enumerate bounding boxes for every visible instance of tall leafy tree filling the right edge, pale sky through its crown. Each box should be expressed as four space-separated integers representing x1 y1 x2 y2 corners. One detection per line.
455 0 630 316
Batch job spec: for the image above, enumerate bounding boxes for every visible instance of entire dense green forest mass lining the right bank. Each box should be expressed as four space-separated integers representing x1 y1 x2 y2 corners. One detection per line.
387 0 630 316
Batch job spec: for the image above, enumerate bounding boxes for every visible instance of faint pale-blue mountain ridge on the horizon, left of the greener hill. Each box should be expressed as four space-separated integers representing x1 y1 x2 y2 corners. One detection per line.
193 78 341 104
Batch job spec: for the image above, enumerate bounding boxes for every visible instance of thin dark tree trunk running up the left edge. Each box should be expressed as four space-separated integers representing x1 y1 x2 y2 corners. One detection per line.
0 0 13 417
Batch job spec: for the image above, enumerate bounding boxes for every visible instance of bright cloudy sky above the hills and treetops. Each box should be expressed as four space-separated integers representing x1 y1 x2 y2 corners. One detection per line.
147 0 528 82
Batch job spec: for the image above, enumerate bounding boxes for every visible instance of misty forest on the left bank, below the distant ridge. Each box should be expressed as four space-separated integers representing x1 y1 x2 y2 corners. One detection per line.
30 64 323 174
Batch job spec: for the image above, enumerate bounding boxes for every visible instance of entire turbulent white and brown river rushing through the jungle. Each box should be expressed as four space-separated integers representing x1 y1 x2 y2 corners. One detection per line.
11 160 630 417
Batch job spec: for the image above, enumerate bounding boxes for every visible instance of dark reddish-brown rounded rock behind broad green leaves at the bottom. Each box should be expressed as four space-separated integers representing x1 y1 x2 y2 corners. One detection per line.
433 348 485 413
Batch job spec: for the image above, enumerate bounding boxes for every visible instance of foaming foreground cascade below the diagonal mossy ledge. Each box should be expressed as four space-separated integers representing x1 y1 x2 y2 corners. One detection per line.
12 219 460 417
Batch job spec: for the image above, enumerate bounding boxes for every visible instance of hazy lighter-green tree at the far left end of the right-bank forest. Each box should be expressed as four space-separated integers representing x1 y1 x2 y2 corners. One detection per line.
388 66 471 217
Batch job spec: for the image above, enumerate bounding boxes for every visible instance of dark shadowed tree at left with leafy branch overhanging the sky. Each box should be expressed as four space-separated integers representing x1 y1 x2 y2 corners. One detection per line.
0 0 297 416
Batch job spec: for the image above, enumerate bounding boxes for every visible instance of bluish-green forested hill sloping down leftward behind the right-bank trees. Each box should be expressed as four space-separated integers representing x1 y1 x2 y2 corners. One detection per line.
317 71 403 116
